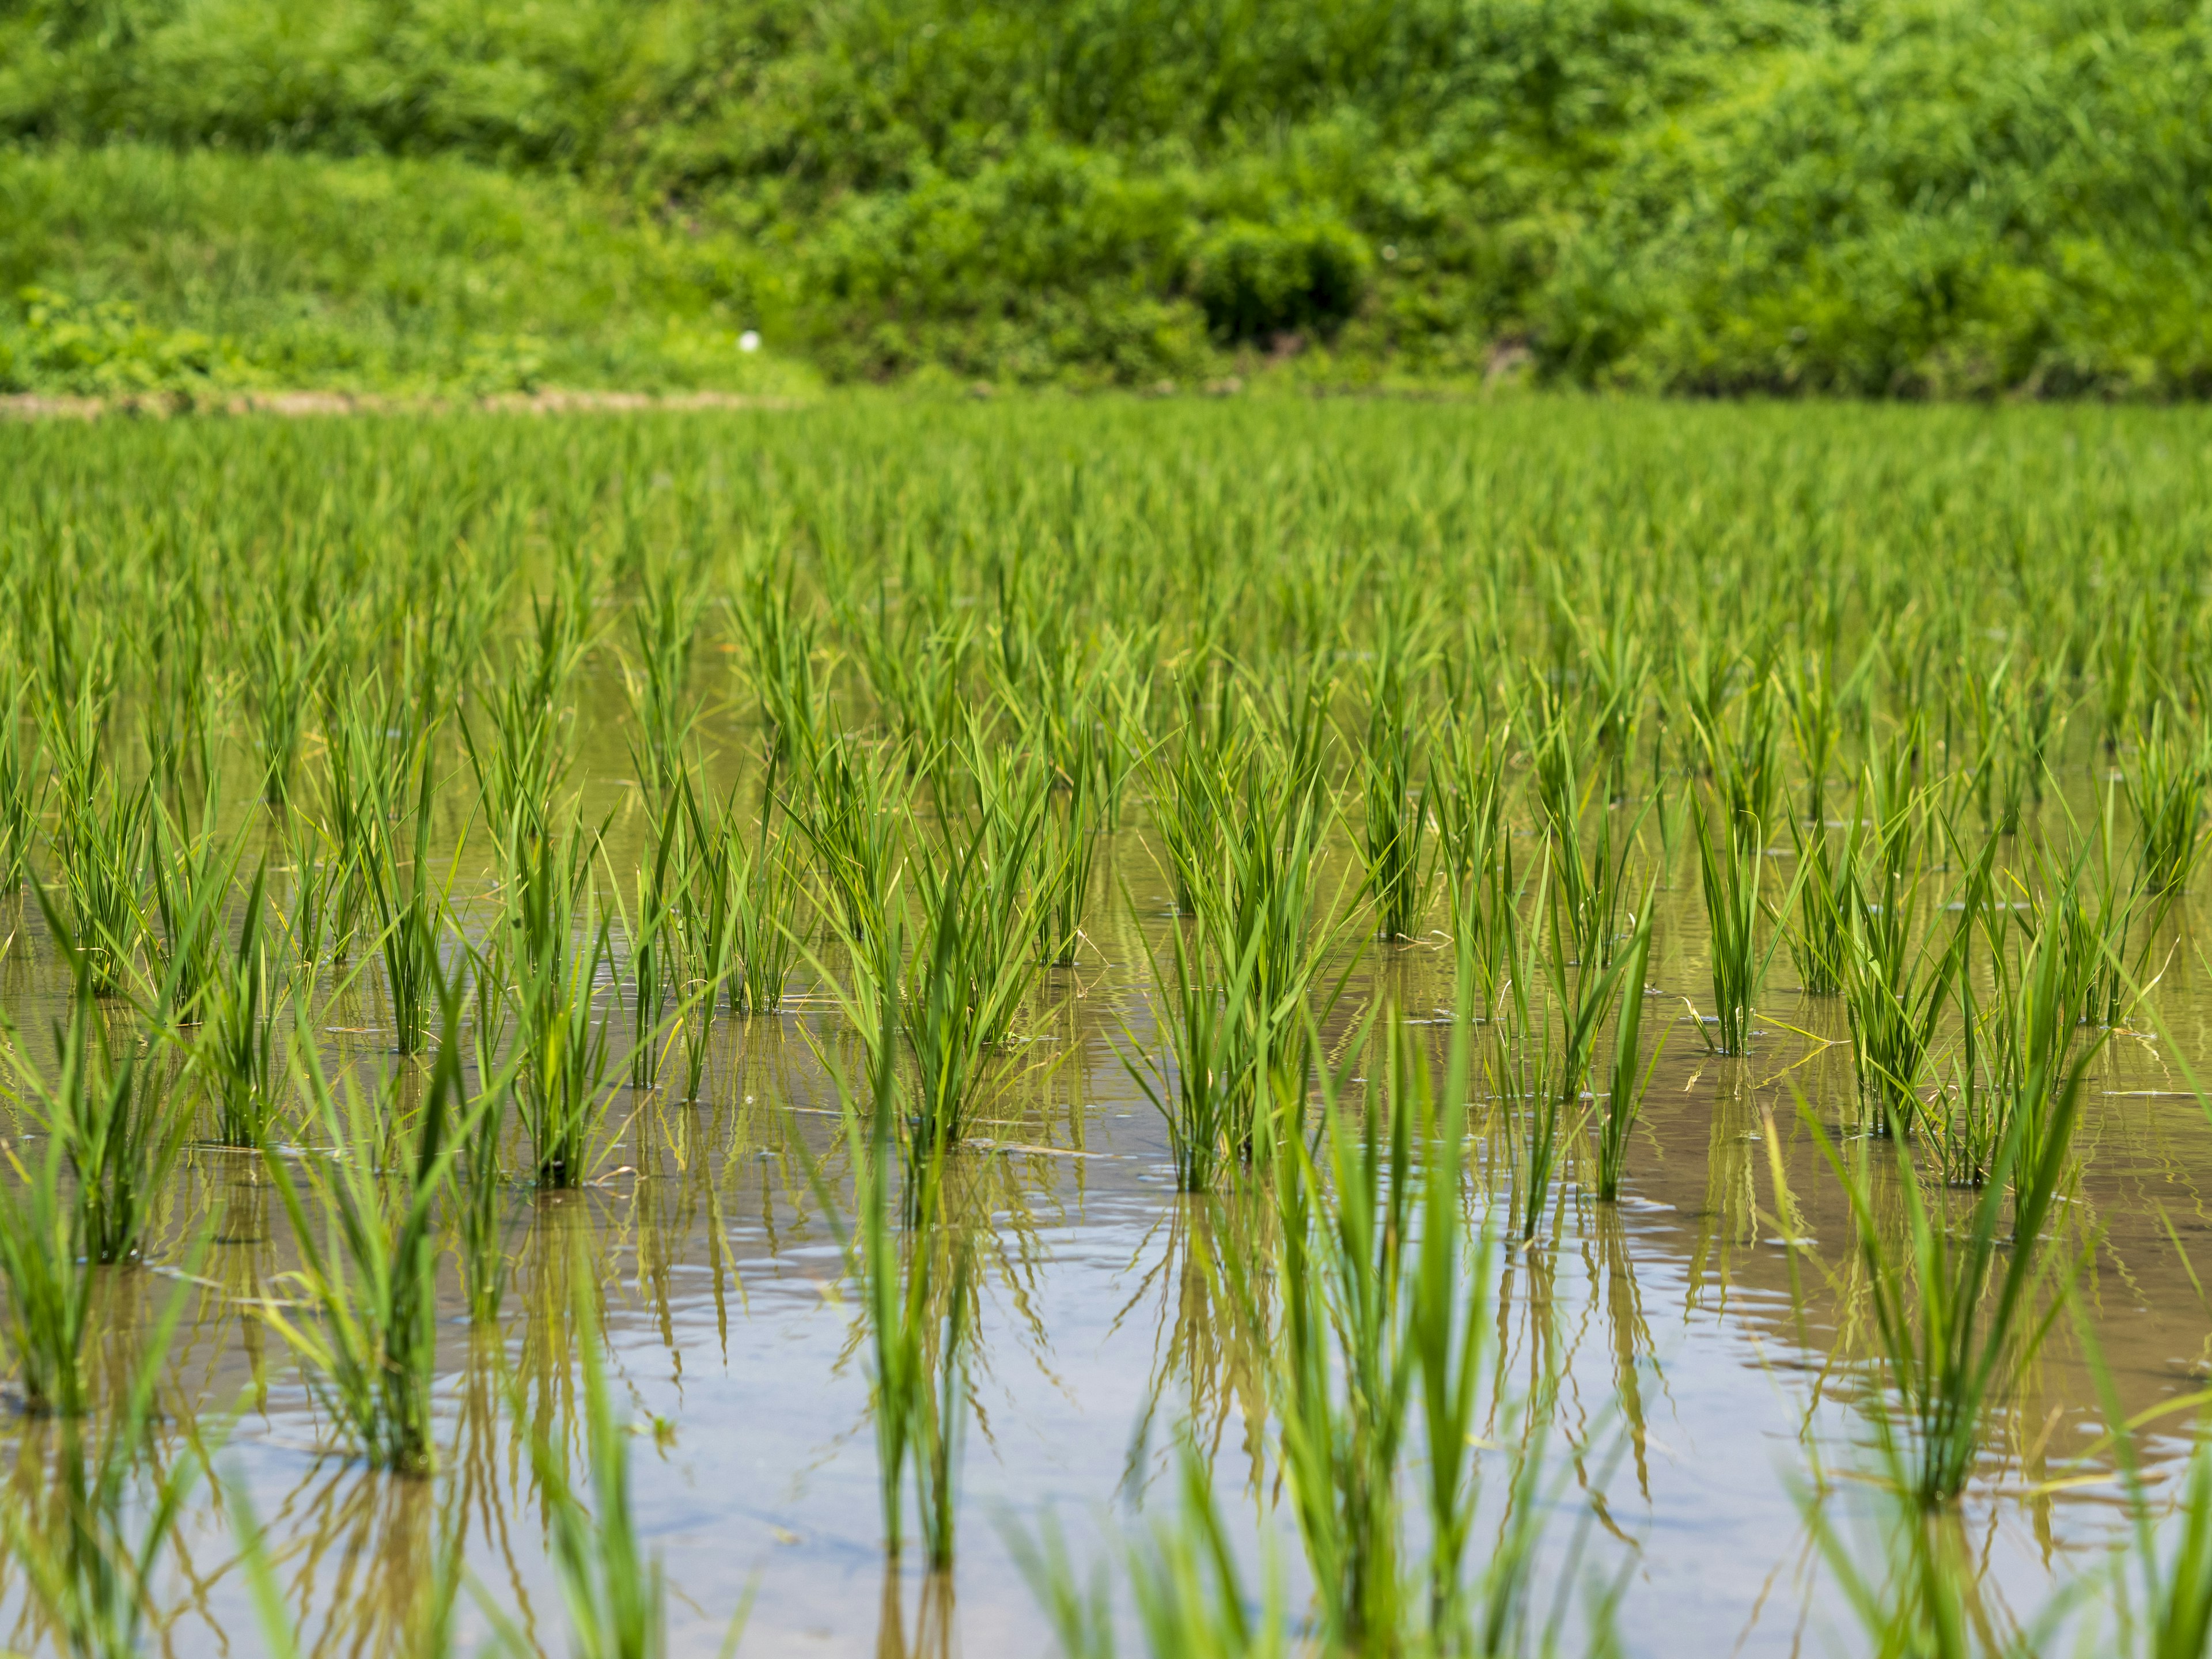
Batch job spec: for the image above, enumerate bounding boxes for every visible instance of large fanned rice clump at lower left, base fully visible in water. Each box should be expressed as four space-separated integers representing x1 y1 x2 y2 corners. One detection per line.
255 982 469 1475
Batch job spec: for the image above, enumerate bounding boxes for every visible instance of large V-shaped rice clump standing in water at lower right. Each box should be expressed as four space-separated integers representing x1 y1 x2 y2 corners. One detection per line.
1801 1044 2097 1509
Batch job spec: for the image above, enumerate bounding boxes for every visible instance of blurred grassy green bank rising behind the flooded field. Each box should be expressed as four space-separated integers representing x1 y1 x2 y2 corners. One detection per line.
0 0 2212 396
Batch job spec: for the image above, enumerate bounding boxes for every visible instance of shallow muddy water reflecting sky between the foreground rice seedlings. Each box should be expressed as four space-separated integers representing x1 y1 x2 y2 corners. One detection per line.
0 677 2212 1654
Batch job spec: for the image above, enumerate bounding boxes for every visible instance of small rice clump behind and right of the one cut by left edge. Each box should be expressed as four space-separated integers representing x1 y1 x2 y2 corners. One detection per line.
9 942 192 1265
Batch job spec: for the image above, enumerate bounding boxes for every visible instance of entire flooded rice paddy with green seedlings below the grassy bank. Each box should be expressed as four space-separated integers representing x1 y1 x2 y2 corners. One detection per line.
0 398 2212 1659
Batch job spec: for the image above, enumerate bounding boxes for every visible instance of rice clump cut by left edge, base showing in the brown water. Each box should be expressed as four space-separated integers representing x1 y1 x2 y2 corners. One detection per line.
0 1119 95 1416
